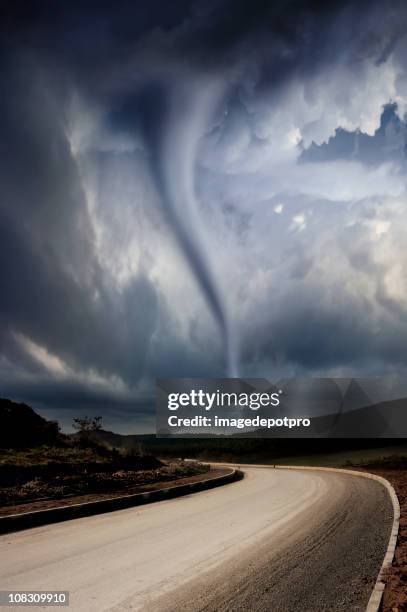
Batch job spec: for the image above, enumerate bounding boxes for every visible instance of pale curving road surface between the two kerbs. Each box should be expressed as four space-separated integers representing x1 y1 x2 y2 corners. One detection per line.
0 468 392 612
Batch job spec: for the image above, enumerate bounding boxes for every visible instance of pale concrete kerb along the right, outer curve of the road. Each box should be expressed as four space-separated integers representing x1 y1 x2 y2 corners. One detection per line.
274 465 400 612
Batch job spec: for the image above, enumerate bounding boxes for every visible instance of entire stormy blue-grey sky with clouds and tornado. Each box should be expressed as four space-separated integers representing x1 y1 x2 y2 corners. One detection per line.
0 0 407 433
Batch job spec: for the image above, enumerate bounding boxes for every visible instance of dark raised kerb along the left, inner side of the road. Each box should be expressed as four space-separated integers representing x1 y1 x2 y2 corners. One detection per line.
0 468 244 535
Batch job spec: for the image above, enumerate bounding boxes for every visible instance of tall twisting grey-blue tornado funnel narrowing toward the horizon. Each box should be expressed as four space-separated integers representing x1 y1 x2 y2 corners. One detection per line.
139 74 238 378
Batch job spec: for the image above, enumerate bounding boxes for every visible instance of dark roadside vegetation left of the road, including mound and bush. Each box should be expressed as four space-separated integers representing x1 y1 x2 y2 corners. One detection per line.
0 400 209 514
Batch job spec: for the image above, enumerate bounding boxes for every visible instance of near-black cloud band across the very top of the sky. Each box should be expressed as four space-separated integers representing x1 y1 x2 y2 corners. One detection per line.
3 0 406 92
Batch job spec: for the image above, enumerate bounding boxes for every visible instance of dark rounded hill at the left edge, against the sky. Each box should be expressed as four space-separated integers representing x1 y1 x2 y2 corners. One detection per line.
0 398 60 448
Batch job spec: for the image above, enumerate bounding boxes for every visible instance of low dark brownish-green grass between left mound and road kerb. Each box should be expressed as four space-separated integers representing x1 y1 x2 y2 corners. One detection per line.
0 443 209 507
